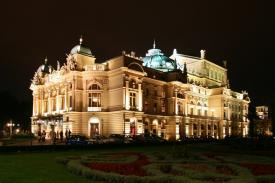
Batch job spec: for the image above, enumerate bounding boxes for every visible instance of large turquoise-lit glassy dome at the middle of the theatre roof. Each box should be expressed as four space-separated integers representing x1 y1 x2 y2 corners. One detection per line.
142 42 176 72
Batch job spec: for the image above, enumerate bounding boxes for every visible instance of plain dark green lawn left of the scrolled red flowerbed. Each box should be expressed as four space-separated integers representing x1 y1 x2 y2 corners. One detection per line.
0 151 102 183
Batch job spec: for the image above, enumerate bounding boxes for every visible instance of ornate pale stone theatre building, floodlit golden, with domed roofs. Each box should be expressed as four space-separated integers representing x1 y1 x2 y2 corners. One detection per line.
30 39 250 139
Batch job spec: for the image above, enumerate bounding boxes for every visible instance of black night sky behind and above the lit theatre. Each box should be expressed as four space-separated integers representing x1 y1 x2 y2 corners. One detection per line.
0 0 275 104
